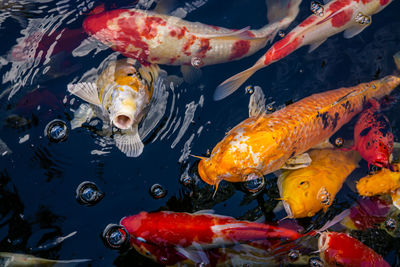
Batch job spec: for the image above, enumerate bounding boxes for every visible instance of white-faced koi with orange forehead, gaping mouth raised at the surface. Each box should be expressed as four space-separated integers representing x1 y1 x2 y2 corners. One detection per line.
68 59 160 157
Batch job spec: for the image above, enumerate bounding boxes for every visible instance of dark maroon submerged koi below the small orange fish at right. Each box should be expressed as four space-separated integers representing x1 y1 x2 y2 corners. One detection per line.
340 197 391 230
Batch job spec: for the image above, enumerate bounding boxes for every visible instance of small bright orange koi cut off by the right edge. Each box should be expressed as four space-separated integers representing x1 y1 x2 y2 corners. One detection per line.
356 163 400 197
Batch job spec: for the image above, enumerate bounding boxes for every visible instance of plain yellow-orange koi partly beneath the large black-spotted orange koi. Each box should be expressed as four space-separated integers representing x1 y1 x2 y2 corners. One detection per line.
278 149 360 218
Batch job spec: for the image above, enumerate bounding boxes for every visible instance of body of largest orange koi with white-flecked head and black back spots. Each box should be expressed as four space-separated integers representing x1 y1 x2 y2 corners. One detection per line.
198 76 400 185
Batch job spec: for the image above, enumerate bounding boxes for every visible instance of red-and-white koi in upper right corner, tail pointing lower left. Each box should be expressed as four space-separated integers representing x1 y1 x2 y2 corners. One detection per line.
214 0 392 100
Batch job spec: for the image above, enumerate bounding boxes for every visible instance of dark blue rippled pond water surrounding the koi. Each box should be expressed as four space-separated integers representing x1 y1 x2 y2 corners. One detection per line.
0 0 400 266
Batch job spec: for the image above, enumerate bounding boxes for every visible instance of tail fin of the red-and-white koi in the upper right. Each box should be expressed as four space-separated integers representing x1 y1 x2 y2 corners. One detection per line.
214 63 264 101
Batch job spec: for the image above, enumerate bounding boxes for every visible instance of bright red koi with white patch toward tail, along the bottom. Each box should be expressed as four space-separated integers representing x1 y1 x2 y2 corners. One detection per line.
120 211 302 265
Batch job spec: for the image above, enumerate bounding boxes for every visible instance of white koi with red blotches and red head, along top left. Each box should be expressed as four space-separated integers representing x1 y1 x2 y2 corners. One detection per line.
83 0 301 67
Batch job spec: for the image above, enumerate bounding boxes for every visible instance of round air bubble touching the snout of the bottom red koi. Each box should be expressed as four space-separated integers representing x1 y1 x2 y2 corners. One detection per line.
102 224 129 249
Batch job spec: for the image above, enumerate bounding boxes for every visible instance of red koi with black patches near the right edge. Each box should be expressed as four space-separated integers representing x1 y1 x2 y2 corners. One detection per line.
349 99 394 168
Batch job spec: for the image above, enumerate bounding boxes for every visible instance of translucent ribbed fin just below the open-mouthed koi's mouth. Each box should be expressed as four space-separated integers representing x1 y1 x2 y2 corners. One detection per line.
114 125 144 158
